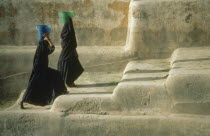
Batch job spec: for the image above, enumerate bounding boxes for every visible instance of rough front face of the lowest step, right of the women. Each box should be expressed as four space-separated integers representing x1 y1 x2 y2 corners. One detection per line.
51 93 113 114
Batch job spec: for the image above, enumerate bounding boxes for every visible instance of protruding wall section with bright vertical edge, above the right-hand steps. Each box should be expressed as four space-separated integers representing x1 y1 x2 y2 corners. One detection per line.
126 0 210 58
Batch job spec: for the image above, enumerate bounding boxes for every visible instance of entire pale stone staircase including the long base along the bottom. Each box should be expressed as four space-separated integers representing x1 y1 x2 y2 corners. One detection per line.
0 47 210 136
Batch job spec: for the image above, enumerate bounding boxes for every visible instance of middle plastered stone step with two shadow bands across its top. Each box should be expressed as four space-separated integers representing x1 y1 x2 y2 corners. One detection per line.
112 59 171 112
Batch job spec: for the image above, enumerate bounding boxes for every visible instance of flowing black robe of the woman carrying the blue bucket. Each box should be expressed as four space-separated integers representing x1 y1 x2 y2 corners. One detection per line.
23 40 66 106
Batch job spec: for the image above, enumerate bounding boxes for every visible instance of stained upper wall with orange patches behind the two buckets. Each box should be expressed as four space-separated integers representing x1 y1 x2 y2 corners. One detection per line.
0 0 130 46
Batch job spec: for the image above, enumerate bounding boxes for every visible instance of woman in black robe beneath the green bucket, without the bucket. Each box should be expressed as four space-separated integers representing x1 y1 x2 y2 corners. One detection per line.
58 17 84 87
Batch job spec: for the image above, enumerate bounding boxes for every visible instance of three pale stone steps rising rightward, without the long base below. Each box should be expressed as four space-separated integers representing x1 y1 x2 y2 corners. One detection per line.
51 47 210 114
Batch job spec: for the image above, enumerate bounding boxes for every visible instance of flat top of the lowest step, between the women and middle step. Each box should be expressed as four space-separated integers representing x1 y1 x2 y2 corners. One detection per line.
68 71 122 94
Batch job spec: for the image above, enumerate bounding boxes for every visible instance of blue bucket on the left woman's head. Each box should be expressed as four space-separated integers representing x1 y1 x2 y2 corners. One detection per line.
36 25 51 40
